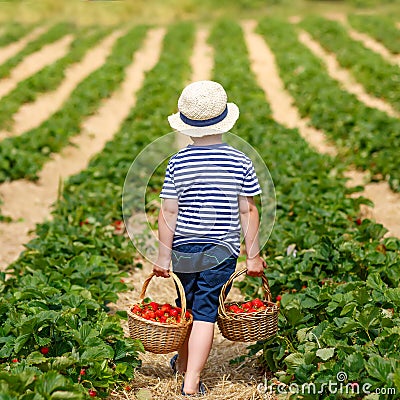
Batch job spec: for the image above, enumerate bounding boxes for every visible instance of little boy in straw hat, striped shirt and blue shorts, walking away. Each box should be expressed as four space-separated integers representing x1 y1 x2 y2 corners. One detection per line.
153 81 266 395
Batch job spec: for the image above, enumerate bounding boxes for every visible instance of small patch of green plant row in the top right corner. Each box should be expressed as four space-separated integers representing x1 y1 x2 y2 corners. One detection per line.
348 14 400 54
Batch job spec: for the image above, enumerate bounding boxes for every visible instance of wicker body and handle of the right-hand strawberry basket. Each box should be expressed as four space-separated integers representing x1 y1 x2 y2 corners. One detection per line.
217 268 279 342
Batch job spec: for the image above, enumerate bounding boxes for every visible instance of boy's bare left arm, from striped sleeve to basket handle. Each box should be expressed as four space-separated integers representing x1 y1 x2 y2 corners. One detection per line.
153 199 178 278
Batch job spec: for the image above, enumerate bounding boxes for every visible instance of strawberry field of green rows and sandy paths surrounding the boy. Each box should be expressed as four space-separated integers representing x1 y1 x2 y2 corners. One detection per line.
0 2 400 400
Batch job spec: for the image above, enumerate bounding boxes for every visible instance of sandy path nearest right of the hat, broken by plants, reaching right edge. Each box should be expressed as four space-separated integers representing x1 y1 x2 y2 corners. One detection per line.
243 21 400 237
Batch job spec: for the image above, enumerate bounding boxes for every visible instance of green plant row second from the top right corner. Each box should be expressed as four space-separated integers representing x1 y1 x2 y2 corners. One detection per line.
301 16 400 110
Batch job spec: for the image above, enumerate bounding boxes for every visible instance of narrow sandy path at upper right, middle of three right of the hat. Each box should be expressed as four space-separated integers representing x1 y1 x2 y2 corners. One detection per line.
299 30 400 118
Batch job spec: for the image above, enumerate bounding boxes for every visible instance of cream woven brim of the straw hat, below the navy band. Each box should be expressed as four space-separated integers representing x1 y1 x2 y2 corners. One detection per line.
168 103 239 137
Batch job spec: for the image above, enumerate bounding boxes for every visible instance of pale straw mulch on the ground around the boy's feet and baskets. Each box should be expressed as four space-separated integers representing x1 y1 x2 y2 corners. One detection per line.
109 262 277 400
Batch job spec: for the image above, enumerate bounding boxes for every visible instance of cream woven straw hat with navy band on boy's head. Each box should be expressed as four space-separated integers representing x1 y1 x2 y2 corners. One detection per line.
168 81 239 137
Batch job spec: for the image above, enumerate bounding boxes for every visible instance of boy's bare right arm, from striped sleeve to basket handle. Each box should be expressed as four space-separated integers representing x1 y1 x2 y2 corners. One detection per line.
239 196 267 276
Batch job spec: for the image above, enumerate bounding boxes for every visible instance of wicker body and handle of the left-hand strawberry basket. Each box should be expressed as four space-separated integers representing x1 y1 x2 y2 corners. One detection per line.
128 271 193 354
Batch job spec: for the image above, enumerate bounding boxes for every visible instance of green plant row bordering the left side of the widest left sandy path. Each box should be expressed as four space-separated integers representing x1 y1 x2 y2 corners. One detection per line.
0 26 146 182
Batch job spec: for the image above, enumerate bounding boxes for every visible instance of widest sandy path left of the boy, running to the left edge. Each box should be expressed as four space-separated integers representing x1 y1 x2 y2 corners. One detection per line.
0 29 164 268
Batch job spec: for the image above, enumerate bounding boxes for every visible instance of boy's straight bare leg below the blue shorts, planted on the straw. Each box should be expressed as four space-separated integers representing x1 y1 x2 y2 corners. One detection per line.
183 321 214 394
